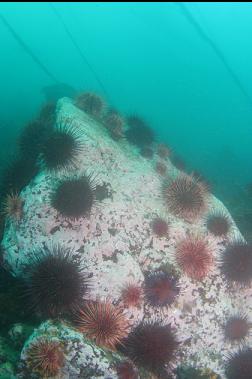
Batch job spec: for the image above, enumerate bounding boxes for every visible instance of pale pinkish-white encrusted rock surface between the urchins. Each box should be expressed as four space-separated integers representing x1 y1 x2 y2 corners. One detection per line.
3 98 252 379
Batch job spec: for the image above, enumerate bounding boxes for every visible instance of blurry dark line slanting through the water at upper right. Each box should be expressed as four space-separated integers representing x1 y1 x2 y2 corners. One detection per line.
175 3 252 106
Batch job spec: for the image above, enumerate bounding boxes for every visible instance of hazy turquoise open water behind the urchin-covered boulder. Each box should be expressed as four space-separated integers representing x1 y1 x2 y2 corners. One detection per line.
0 2 252 379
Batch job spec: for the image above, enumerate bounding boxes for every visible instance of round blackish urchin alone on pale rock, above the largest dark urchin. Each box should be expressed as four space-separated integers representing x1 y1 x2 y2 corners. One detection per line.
51 175 95 220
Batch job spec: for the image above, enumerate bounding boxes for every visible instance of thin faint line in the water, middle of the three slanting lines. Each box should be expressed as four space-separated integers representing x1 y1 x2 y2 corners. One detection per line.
49 2 108 99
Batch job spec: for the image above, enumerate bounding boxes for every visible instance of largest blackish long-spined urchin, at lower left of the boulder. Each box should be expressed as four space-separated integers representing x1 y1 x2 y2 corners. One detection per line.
24 245 89 318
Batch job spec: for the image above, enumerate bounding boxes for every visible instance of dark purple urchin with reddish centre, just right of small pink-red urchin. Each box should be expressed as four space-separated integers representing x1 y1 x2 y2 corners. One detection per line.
144 271 180 307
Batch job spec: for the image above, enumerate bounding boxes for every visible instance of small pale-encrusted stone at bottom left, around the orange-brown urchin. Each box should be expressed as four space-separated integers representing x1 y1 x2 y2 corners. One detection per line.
20 321 121 379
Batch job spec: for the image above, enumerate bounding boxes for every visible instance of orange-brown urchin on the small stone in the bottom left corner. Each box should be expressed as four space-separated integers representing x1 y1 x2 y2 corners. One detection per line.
26 338 65 378
